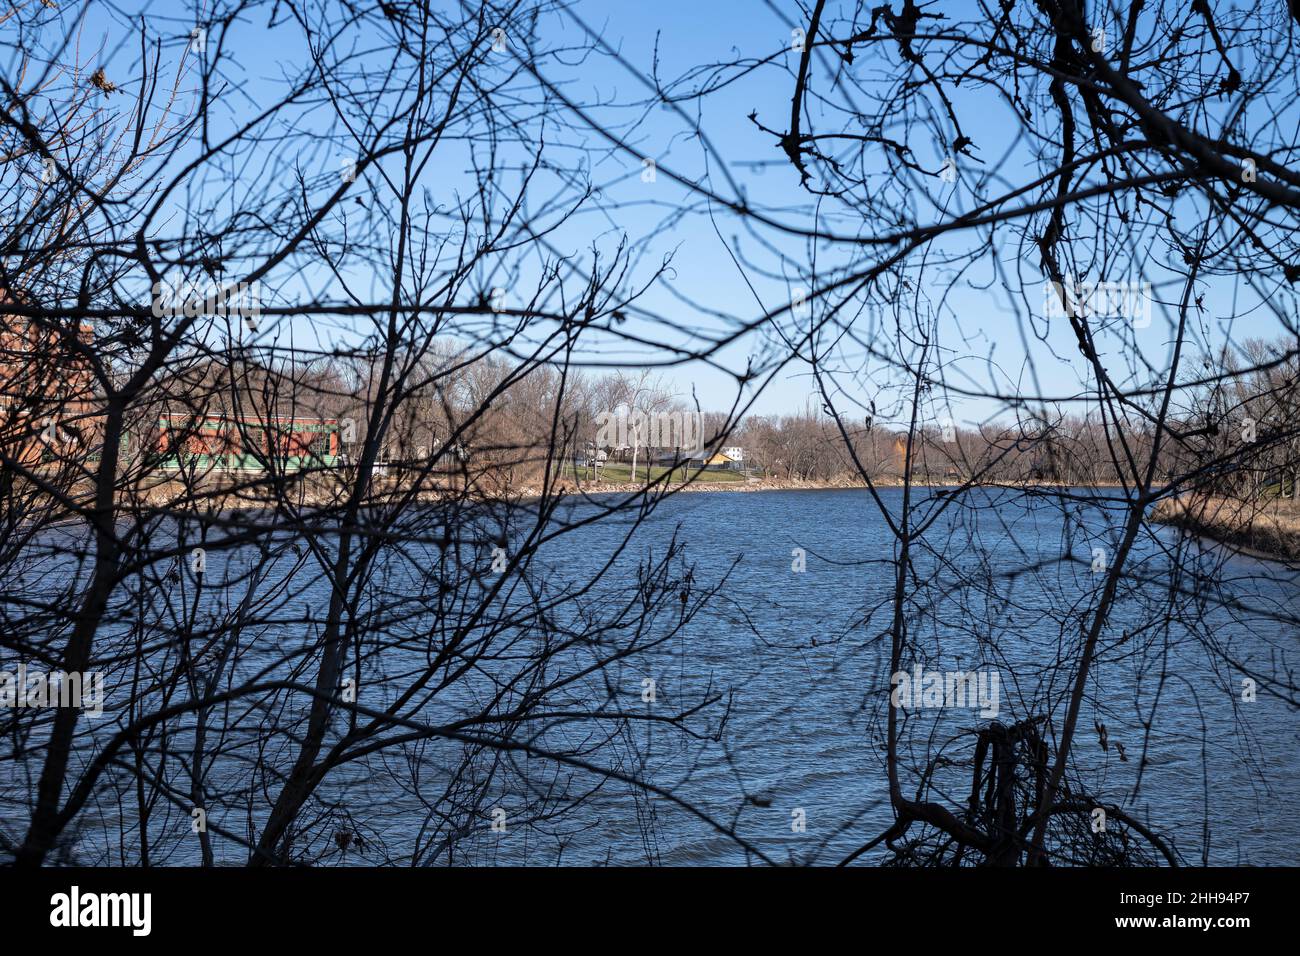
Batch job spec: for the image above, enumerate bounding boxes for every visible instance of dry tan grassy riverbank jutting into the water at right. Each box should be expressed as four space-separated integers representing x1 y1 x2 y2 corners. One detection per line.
1149 494 1300 562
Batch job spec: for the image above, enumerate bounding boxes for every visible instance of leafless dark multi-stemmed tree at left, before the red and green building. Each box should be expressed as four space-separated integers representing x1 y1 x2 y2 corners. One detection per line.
0 3 762 865
